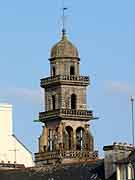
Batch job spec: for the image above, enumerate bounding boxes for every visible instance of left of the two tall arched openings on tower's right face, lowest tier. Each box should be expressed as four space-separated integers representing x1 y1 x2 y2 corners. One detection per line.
66 126 73 150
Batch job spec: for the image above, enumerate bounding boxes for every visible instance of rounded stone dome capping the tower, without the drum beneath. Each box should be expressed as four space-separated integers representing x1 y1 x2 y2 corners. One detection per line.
51 34 79 59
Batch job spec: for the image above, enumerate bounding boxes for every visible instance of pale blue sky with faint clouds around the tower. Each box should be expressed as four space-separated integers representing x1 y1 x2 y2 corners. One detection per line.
0 0 135 156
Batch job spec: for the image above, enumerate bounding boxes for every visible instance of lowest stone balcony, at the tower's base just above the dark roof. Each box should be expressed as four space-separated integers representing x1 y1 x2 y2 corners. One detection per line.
35 150 98 162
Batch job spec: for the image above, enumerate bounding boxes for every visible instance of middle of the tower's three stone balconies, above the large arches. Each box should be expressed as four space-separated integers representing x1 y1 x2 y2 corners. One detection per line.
39 109 93 122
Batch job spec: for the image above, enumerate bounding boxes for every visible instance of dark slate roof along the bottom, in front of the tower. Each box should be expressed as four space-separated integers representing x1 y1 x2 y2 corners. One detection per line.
0 160 105 180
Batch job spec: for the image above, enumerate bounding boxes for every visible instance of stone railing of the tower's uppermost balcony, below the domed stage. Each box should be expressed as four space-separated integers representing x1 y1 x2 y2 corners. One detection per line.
41 75 90 87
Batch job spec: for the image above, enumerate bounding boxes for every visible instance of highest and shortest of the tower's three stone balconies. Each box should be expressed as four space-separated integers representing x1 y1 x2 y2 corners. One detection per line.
41 75 90 88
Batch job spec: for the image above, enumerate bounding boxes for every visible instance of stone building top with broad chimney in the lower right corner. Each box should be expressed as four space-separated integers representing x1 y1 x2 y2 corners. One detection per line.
104 143 135 180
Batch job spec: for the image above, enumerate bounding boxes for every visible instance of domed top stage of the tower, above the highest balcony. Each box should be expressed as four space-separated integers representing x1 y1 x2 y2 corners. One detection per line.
49 30 80 76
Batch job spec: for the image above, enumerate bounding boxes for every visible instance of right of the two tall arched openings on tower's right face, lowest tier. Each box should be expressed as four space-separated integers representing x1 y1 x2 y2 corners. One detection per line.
76 127 85 151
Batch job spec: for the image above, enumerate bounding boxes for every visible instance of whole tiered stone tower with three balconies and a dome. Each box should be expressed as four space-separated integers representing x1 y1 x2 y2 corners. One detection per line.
35 31 98 165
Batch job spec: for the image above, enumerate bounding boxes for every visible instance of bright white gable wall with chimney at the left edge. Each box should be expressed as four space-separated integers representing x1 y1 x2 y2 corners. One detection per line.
0 104 34 167
